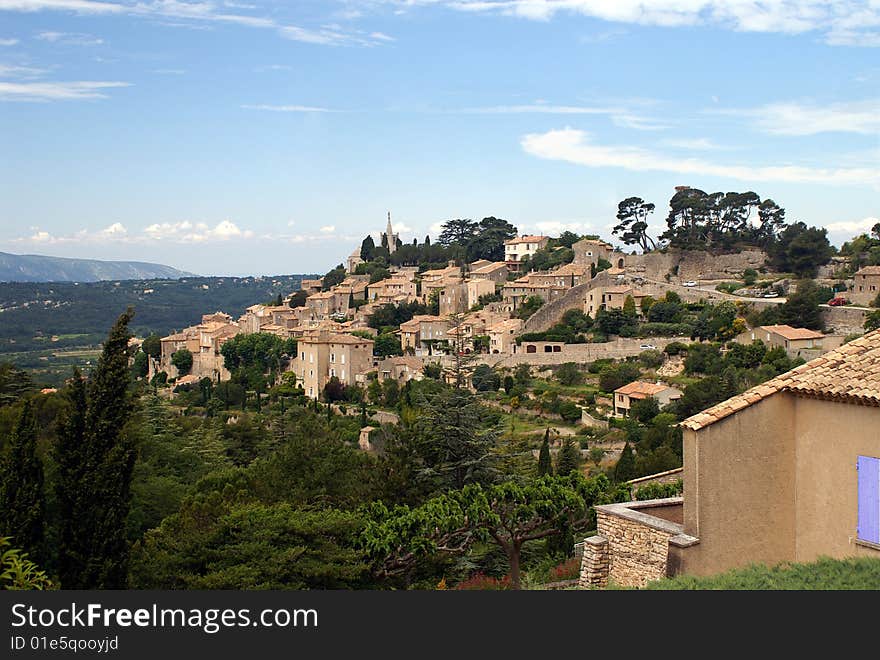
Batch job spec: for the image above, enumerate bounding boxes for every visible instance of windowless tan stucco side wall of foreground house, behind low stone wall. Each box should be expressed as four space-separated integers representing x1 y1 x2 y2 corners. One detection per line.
680 394 795 575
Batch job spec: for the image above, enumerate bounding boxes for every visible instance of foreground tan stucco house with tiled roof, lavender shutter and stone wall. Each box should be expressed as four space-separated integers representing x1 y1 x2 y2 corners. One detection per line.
581 331 880 586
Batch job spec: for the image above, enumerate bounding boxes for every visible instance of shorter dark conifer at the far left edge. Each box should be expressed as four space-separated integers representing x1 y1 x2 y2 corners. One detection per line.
0 401 45 558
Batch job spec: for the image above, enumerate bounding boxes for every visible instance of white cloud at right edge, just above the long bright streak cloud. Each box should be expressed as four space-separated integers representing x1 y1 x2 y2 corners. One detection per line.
709 99 880 135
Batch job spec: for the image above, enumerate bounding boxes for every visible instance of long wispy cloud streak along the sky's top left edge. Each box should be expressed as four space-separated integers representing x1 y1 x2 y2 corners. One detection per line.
0 0 391 46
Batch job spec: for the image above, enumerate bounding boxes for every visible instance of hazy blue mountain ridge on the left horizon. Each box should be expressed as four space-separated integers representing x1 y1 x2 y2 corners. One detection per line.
0 252 194 282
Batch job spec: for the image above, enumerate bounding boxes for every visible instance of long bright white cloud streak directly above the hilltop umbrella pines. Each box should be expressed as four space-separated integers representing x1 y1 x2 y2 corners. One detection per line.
520 128 880 186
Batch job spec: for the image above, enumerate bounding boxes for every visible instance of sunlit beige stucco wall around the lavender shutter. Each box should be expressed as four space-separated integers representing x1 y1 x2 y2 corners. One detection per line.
794 397 880 561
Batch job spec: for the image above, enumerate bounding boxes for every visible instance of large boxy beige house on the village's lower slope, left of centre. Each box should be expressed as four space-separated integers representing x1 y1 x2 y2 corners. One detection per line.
290 330 373 399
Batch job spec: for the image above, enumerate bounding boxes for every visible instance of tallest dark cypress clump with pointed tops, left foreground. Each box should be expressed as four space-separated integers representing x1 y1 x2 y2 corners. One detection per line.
56 308 136 589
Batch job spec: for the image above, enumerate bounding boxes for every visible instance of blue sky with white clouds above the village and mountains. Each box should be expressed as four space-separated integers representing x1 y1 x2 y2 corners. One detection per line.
0 0 880 274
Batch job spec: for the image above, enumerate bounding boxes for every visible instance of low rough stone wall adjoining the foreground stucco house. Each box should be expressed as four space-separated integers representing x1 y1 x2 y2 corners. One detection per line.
579 497 684 588
